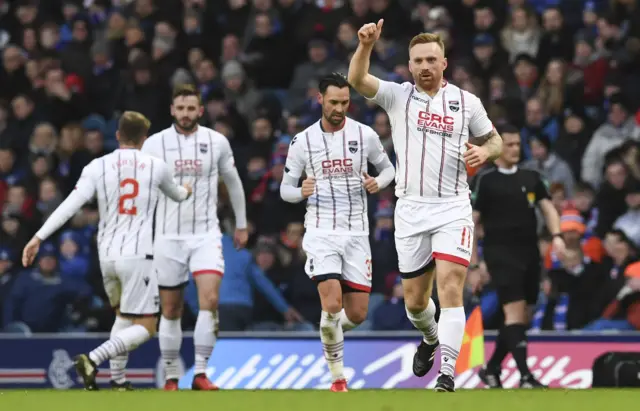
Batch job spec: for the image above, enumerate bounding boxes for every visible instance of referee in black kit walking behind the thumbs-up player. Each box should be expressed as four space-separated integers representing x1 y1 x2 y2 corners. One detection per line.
469 126 565 388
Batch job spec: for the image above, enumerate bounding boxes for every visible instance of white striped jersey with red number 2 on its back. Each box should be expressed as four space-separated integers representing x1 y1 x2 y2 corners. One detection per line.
36 149 187 261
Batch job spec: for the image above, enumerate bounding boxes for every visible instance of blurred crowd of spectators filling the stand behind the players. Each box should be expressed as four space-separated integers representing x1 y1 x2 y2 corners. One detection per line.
0 0 640 332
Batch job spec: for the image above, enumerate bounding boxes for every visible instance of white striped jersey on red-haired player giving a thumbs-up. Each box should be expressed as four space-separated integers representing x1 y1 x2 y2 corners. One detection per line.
371 80 493 202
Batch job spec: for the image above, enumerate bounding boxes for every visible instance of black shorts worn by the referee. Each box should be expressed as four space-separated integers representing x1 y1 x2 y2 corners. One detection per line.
483 246 541 305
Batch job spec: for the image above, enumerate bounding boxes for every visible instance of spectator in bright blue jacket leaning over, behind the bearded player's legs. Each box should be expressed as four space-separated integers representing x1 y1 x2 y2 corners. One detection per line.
185 235 302 331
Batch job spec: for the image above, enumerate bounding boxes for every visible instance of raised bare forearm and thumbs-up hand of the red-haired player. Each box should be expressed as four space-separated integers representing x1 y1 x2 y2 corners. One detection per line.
347 19 384 99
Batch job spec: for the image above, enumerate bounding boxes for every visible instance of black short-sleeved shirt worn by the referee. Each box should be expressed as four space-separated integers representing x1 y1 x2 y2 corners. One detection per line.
472 167 550 247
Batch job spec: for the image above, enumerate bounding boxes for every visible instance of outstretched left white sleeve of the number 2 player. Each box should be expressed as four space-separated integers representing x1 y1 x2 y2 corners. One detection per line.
36 160 98 241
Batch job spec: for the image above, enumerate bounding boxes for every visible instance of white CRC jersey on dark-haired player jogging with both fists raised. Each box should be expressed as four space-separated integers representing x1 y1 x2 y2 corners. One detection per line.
285 118 387 235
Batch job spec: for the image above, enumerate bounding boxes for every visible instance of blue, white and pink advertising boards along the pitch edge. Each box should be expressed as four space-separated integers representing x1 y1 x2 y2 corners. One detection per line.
0 333 640 389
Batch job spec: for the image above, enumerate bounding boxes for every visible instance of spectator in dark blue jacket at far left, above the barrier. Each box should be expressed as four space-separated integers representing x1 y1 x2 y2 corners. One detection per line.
3 243 91 332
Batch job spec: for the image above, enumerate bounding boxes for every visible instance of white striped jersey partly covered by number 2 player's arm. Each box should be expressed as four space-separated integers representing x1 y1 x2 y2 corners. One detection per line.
142 126 235 237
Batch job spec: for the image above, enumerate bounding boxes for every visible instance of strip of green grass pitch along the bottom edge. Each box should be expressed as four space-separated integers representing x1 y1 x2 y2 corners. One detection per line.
0 389 640 411
